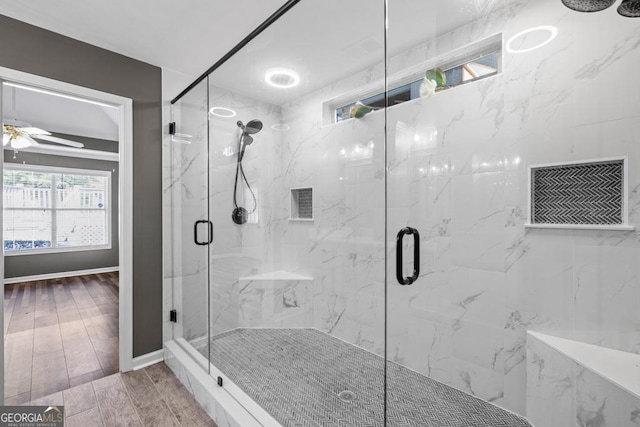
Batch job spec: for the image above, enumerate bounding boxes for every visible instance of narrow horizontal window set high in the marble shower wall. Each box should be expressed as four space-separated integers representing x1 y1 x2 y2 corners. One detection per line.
334 37 502 123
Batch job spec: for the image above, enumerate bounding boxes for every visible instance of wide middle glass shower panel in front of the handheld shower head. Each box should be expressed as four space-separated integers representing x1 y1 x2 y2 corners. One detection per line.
202 0 384 426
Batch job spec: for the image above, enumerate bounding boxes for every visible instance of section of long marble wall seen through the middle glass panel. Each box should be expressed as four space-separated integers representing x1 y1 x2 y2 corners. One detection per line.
282 74 385 354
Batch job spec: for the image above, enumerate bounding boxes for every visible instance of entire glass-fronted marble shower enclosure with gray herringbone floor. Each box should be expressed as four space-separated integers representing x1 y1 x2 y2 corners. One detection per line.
164 0 640 426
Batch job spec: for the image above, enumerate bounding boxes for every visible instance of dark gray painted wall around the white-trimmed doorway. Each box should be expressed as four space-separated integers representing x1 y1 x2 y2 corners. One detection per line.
0 15 162 357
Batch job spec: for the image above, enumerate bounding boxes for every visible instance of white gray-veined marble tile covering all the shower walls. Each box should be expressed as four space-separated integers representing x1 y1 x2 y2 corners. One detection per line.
163 0 640 418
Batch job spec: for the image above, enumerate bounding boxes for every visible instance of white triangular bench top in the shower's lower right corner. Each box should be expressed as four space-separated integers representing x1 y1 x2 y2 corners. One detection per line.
527 331 640 398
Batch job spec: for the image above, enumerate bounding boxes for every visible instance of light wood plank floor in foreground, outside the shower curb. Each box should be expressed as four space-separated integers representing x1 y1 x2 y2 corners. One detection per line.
30 362 217 427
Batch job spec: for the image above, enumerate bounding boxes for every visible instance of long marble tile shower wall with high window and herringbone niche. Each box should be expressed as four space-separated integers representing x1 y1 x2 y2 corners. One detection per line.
282 0 640 414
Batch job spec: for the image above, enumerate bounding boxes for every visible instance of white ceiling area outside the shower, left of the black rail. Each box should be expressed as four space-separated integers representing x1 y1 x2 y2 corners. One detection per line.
0 0 285 83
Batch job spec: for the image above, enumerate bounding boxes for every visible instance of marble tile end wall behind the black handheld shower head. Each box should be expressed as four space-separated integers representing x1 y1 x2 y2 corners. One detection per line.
209 86 288 335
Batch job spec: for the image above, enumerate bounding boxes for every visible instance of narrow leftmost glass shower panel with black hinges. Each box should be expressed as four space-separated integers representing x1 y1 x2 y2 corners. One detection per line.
165 80 213 372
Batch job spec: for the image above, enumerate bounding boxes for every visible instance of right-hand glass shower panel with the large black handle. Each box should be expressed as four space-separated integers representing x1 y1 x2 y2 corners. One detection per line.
387 0 640 426
